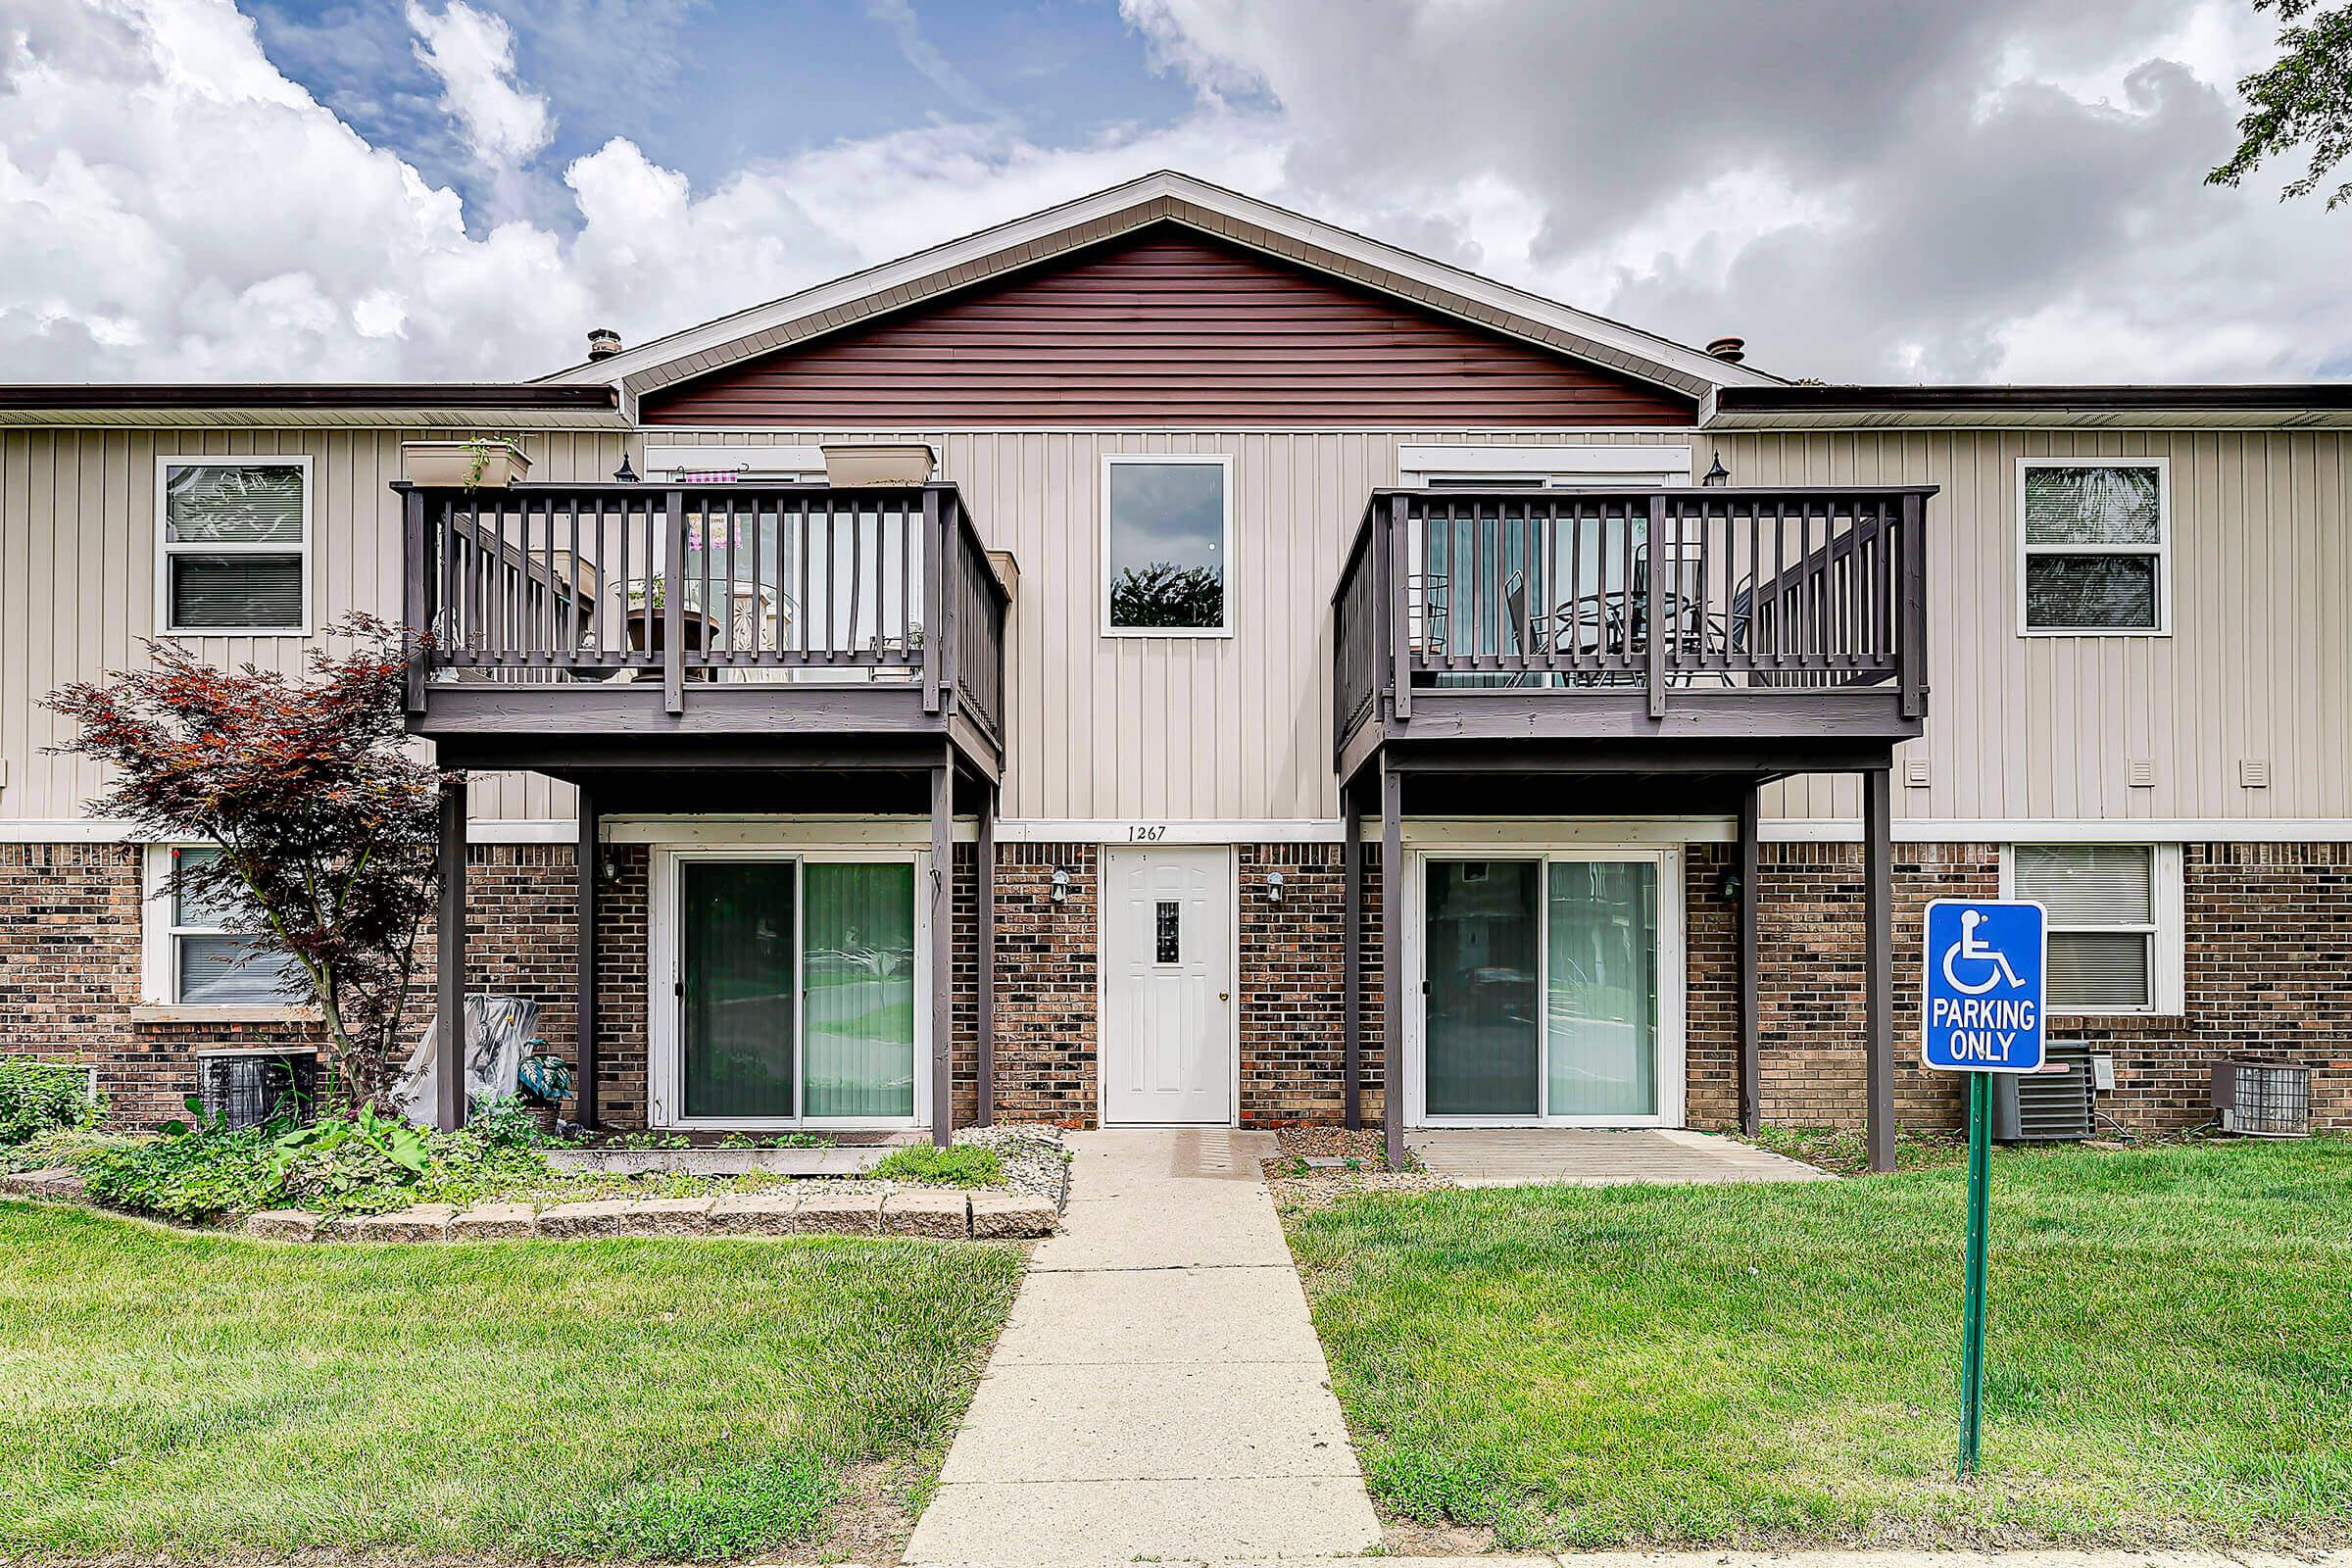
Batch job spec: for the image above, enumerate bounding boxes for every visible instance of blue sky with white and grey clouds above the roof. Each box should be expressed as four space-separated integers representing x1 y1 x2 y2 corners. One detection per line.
0 0 2352 381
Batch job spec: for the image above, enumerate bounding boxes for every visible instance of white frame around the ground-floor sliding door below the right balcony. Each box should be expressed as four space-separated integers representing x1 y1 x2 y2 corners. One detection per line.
1399 839 1691 1128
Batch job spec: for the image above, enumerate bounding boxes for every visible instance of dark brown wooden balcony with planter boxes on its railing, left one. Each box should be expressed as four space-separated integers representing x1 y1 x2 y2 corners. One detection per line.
398 484 1011 780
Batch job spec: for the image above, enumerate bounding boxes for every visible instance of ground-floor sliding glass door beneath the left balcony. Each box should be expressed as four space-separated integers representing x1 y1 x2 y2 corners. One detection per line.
654 851 924 1128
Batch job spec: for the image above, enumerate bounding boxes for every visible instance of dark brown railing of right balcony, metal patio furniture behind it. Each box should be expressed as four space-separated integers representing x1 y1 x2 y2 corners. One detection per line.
1331 487 1934 748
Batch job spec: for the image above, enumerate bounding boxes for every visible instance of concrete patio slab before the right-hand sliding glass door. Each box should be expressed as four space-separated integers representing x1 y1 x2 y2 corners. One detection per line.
1404 1126 1837 1187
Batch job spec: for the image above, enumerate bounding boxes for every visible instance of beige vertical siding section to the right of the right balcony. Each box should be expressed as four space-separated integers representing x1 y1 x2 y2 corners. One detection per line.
1707 430 2352 820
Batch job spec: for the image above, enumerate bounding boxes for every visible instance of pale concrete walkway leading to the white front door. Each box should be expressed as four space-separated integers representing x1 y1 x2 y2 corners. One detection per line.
906 1128 1381 1568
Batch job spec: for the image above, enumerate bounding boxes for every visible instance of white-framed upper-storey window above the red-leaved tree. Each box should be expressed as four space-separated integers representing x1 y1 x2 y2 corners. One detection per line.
155 459 311 637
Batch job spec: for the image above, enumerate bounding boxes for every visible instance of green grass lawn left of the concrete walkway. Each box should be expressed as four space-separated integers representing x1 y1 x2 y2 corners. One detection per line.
0 1201 1021 1561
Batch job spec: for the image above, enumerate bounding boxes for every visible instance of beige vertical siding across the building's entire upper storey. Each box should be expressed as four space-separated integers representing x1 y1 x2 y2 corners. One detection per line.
0 416 2352 820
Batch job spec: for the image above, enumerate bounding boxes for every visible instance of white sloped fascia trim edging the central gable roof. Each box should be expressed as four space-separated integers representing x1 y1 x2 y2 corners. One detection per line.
541 170 1783 395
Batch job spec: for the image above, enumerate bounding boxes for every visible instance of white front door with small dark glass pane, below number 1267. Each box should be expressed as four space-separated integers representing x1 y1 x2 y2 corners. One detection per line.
1099 849 1235 1126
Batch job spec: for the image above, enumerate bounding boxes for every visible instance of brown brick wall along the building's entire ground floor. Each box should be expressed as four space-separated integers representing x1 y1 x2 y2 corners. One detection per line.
14 844 2352 1131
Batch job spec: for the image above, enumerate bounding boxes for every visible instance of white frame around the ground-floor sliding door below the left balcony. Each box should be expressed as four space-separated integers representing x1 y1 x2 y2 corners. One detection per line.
645 839 931 1133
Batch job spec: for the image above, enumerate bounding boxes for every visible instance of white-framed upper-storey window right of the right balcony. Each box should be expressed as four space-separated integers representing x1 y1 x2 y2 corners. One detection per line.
2018 459 2174 637
